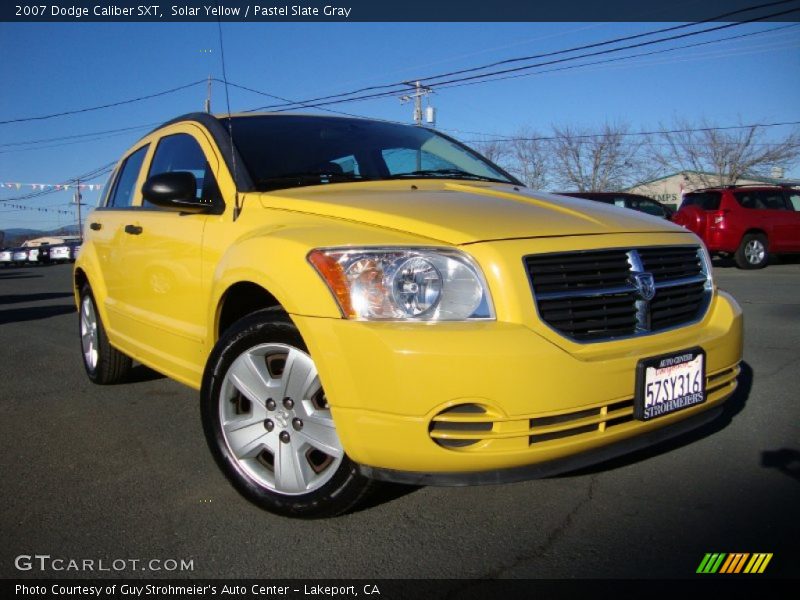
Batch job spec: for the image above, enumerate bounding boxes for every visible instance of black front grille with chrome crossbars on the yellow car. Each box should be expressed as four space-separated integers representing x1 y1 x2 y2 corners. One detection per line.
525 246 710 342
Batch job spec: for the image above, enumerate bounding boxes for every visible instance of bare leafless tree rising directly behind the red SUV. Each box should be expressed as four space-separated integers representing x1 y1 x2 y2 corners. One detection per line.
652 119 800 187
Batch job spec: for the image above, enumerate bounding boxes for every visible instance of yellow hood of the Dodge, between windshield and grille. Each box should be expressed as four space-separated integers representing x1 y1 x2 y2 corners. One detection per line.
257 179 684 245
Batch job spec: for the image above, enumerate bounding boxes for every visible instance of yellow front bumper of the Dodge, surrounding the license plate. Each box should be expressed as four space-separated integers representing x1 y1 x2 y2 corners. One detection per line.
292 293 742 483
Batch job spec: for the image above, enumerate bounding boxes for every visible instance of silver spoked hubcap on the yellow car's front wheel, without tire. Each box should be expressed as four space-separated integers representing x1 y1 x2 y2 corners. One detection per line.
219 344 344 496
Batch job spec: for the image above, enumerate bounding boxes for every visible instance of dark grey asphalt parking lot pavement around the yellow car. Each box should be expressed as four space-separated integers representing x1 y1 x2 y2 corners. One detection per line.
0 261 800 578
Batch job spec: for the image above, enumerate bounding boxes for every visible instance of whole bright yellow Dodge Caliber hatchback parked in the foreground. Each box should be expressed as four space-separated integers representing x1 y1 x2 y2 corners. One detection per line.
74 114 742 517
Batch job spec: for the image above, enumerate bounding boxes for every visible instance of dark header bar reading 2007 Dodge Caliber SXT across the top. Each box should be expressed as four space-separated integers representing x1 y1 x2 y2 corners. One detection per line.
0 0 800 23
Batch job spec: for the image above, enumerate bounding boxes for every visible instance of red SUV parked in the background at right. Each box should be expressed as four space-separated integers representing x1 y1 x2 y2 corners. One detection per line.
672 185 800 269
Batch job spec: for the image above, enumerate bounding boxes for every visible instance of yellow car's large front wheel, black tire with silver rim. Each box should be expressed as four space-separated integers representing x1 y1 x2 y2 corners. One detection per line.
200 309 375 518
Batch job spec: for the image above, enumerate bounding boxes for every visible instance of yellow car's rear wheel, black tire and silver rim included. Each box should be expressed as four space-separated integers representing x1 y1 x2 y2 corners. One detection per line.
78 284 132 385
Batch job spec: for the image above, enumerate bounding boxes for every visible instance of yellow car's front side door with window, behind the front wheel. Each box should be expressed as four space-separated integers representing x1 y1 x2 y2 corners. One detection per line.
114 124 220 386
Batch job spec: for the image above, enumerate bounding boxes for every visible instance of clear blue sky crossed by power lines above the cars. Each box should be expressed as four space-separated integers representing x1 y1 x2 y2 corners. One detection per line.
0 23 800 230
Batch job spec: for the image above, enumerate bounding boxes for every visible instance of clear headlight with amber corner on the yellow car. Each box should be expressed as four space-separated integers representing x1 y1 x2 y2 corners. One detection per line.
308 248 494 321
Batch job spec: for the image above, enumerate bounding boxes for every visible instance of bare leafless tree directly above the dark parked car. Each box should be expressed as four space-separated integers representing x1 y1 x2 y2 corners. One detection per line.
551 123 653 192
